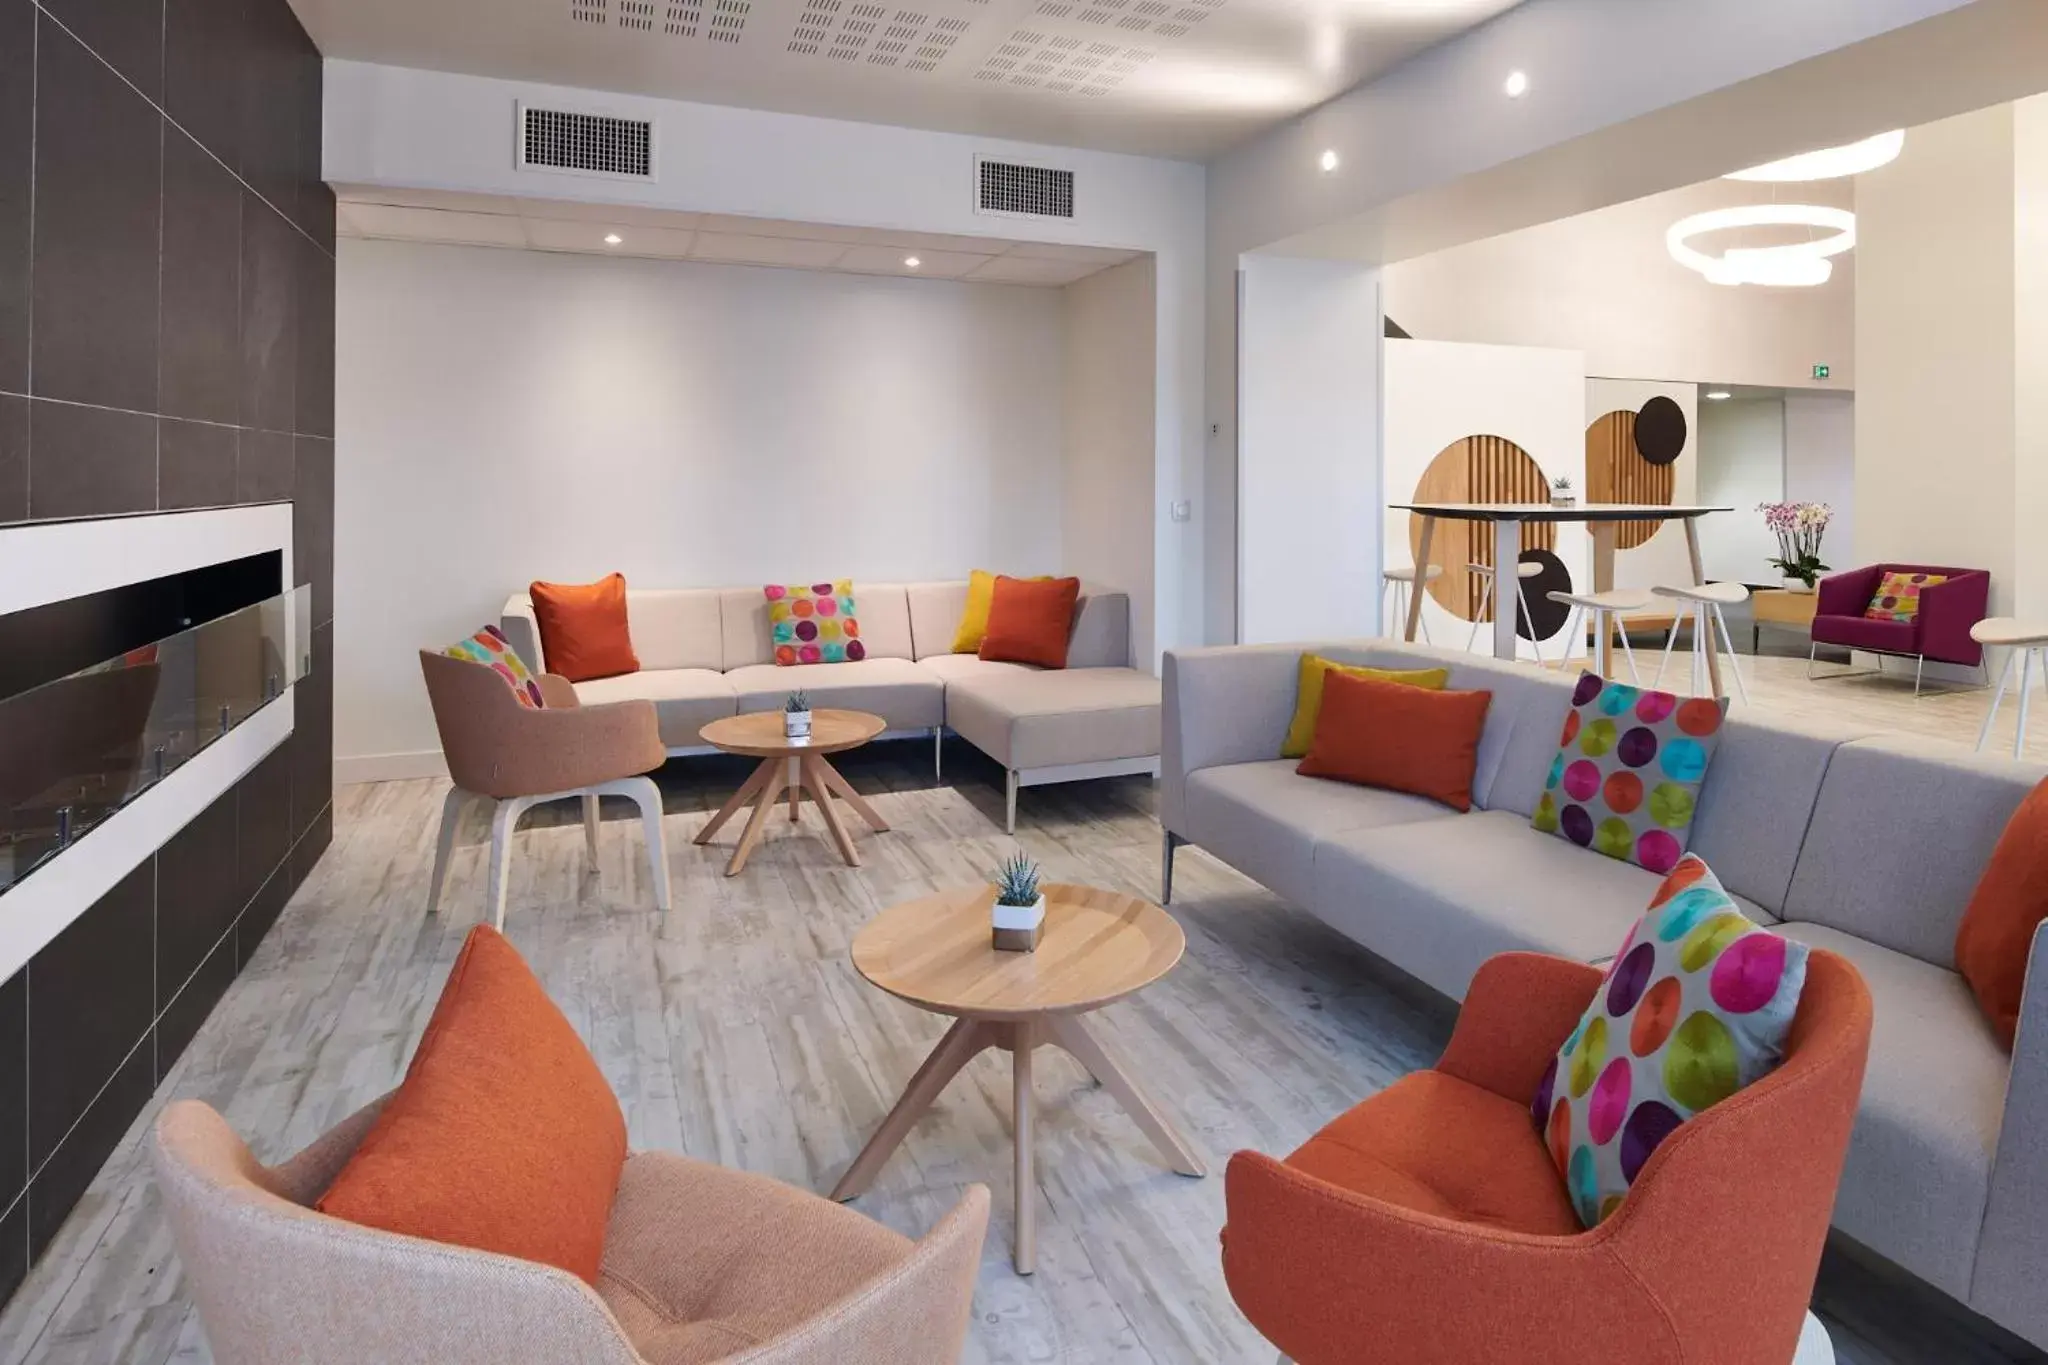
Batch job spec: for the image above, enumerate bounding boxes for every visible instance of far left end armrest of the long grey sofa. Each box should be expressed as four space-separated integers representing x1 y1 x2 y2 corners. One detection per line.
1159 645 1315 835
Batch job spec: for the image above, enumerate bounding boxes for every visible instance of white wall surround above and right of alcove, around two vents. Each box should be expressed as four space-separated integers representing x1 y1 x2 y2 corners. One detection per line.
324 61 1196 663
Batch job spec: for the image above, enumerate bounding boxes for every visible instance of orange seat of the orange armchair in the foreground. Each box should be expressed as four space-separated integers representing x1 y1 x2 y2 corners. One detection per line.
1286 1070 1581 1236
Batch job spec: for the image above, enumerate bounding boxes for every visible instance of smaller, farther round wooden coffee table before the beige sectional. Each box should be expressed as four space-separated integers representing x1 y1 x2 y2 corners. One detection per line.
696 710 889 876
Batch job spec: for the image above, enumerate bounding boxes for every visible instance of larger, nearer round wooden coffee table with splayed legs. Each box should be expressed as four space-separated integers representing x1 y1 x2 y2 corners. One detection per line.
831 884 1208 1275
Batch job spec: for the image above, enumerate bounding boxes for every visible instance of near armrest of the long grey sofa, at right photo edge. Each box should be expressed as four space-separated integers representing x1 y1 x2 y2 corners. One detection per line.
1970 923 2048 1340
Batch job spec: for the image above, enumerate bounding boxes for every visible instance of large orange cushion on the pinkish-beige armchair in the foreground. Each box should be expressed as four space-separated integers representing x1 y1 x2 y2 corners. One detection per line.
313 925 627 1283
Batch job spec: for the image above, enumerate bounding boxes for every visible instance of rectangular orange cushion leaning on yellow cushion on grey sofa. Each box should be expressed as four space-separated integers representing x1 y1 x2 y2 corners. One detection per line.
1294 669 1493 810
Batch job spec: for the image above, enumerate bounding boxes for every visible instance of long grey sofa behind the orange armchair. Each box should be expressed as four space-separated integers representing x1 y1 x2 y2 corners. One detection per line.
1161 641 2048 1347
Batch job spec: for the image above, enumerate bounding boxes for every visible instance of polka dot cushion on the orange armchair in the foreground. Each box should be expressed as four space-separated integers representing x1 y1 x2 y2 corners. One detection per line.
1530 853 1806 1228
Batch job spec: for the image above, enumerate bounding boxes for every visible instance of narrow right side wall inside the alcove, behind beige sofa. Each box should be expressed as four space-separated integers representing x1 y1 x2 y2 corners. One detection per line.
1061 256 1157 667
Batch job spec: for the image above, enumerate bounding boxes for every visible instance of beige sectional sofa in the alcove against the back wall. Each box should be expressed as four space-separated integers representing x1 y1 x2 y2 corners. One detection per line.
500 579 1159 833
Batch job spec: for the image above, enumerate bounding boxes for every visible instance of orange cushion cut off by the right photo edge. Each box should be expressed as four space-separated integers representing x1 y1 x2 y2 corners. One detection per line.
1956 782 2048 1052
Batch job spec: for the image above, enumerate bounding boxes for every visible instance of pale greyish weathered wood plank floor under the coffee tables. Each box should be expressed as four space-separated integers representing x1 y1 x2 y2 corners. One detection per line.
0 679 2048 1365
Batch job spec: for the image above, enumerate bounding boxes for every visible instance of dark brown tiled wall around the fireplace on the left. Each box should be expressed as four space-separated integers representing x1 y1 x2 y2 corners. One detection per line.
0 0 334 1304
